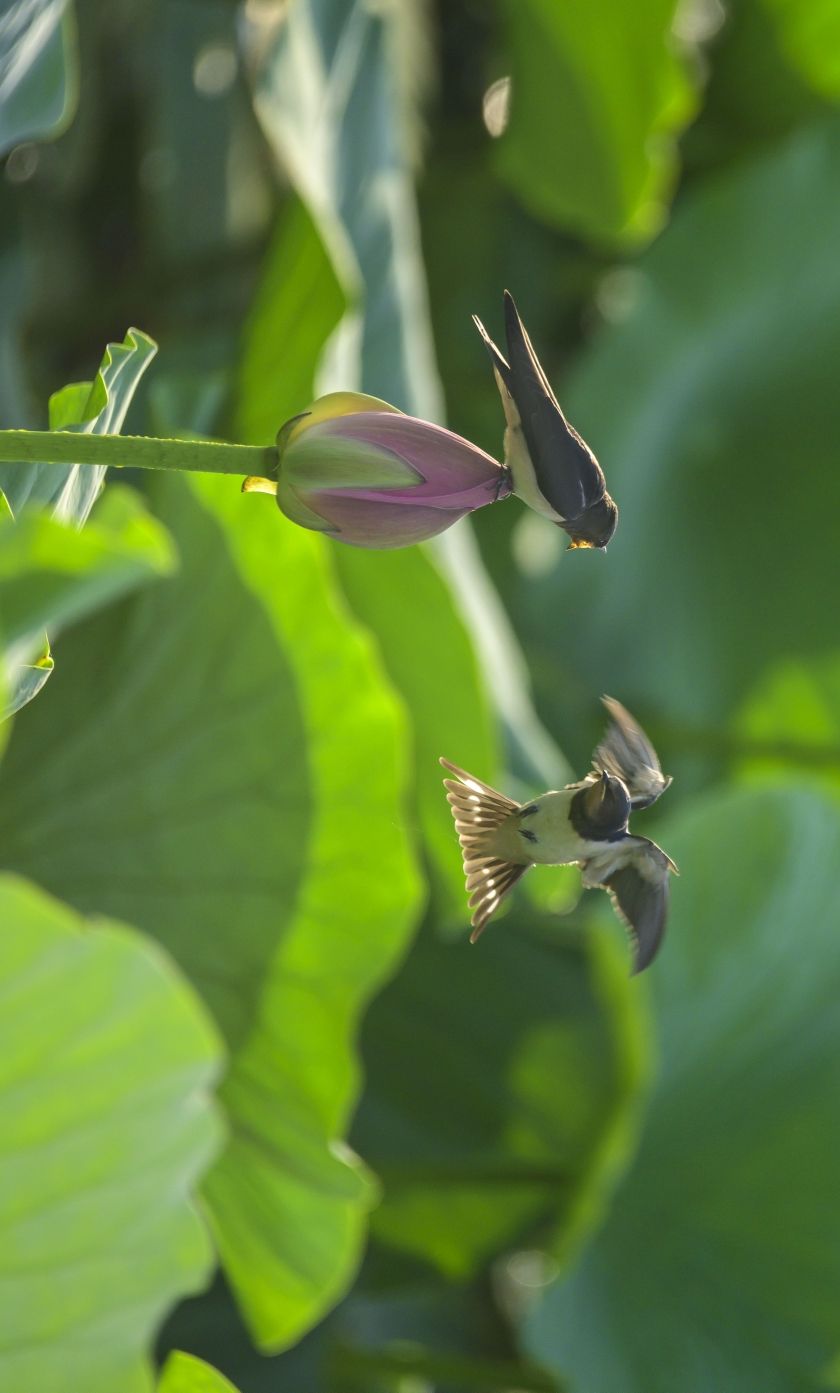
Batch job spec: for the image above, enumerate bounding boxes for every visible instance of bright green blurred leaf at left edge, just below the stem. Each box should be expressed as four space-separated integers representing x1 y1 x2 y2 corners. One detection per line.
0 485 174 690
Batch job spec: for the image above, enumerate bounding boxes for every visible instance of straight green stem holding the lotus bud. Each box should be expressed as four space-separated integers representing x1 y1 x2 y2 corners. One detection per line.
0 430 277 479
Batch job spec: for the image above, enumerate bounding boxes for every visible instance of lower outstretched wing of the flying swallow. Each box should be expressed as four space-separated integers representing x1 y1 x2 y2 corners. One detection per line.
582 837 677 974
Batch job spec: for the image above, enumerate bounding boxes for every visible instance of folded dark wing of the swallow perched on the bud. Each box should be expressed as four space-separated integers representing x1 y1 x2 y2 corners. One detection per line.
504 290 612 523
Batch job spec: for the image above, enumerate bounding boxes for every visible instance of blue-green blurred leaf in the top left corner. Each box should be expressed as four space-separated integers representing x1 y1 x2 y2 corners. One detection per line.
0 0 78 155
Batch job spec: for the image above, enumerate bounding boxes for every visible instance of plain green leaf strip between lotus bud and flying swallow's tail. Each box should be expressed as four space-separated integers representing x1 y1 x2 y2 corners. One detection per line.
333 546 499 928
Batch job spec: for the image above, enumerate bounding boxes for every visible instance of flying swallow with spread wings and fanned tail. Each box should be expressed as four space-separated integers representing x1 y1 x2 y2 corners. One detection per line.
440 697 677 972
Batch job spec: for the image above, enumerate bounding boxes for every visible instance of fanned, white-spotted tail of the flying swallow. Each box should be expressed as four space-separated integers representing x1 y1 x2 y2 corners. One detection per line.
440 759 528 943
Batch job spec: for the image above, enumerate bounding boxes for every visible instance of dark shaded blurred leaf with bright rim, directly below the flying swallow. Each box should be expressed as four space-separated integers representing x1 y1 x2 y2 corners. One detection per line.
354 908 646 1279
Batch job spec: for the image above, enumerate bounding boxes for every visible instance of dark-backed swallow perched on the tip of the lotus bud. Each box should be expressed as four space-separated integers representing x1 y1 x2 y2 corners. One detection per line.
472 290 619 546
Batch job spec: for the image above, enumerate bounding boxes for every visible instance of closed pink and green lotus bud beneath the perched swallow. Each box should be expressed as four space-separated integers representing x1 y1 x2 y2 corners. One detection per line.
244 391 511 547
